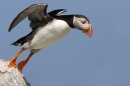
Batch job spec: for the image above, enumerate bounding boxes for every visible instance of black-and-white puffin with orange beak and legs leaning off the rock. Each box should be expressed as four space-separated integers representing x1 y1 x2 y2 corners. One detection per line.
8 3 93 73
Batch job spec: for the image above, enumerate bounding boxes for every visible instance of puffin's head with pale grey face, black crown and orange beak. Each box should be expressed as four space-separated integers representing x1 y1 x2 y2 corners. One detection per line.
73 15 93 37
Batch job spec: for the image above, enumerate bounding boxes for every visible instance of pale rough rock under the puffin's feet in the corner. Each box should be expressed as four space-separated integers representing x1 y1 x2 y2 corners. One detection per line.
0 59 31 86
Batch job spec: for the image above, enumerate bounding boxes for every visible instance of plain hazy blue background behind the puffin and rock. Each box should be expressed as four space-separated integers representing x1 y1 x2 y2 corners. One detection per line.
0 0 130 86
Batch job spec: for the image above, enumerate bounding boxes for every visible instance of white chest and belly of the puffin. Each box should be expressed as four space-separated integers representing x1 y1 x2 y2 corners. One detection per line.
29 20 71 49
